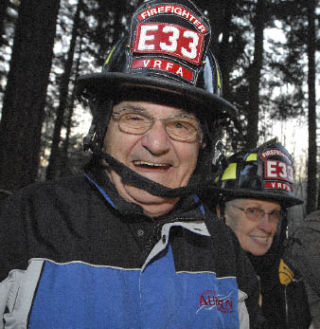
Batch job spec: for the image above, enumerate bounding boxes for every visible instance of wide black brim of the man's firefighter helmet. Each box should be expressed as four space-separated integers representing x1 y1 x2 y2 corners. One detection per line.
77 72 237 121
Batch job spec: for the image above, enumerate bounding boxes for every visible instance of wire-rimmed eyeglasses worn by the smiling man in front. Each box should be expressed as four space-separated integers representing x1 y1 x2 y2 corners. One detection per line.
112 108 202 143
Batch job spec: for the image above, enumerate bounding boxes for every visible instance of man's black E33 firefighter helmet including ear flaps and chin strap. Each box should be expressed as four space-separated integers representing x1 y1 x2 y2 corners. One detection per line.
77 0 236 196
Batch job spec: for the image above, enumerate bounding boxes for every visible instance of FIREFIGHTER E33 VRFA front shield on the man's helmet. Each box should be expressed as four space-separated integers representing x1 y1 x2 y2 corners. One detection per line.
129 0 211 85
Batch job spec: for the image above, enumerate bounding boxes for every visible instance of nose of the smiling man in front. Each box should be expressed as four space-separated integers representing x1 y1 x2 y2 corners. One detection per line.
141 120 171 155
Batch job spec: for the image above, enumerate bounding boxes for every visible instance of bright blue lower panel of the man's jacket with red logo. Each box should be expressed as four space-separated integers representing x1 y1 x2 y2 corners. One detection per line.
29 248 239 329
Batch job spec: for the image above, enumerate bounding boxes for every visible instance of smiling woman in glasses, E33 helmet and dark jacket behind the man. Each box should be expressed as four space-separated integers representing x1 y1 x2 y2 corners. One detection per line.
217 139 310 329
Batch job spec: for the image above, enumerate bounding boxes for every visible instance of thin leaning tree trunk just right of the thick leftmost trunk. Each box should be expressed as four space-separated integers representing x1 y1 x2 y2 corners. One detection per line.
46 0 82 179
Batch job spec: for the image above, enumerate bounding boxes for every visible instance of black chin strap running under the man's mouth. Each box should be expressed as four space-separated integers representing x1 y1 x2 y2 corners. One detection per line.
93 148 219 198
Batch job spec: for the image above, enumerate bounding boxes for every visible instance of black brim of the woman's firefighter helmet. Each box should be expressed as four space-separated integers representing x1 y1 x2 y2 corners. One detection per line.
214 188 303 208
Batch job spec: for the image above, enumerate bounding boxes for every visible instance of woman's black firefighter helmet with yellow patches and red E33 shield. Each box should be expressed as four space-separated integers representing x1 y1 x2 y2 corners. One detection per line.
216 139 303 208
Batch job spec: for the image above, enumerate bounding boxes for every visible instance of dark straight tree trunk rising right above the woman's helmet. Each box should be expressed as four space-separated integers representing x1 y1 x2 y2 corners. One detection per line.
246 0 266 148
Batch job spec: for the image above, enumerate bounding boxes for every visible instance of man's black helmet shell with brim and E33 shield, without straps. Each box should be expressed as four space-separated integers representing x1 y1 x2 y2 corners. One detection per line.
77 0 235 124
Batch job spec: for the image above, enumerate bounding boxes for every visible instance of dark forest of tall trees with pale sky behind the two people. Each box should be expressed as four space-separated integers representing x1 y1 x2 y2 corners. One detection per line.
0 0 320 229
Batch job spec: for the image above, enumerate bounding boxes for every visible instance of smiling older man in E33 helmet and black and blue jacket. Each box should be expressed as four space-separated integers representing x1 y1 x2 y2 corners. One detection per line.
0 0 263 329
